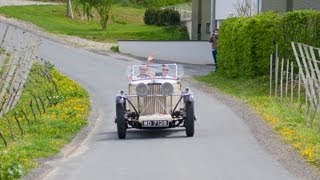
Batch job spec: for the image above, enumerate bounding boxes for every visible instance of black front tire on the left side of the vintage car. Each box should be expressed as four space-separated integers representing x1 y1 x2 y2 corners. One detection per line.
116 103 127 139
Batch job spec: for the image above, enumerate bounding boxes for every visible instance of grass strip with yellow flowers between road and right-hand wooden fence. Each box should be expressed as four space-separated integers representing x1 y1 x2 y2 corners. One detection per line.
195 73 320 170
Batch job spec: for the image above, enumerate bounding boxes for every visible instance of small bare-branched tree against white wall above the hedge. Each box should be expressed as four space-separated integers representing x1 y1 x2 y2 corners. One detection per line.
234 0 255 17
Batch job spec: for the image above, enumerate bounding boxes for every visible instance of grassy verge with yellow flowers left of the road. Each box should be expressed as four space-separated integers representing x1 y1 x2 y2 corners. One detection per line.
0 64 90 179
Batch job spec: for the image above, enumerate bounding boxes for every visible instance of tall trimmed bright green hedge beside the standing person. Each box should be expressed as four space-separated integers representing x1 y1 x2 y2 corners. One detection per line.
218 10 320 77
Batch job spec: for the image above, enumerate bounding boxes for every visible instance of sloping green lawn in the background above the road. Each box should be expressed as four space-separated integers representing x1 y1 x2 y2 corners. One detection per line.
0 5 188 42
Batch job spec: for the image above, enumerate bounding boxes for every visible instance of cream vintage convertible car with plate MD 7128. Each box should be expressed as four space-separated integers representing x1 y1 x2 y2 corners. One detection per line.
115 64 196 139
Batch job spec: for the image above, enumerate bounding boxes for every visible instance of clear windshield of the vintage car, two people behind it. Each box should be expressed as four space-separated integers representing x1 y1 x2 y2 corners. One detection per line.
131 64 178 80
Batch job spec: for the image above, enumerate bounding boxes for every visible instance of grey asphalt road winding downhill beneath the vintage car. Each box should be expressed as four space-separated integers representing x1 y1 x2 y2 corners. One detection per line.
1 23 296 180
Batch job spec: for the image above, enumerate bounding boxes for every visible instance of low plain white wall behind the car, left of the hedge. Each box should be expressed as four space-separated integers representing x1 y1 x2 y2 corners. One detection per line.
118 40 213 64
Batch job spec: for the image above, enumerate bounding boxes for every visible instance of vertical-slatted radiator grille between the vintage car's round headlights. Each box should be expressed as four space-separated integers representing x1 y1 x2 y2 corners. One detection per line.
142 84 167 115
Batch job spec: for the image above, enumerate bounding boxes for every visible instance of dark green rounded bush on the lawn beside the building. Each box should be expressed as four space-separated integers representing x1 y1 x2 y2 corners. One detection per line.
143 9 180 26
